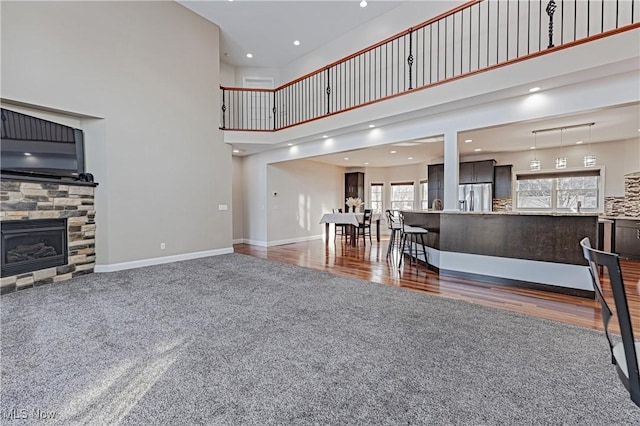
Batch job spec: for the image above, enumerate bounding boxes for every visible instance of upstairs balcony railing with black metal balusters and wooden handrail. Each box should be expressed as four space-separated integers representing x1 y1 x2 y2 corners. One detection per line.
221 0 640 131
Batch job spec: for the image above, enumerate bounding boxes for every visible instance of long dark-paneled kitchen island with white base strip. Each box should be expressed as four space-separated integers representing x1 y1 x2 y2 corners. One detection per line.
404 211 598 298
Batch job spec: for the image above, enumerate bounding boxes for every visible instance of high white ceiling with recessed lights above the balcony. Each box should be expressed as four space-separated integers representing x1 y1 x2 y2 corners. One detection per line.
178 0 403 68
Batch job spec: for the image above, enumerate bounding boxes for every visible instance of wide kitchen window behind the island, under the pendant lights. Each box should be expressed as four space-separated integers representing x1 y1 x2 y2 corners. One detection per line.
516 170 600 211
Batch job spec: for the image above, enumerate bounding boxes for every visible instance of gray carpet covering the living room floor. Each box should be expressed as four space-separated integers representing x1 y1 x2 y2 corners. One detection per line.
0 254 640 425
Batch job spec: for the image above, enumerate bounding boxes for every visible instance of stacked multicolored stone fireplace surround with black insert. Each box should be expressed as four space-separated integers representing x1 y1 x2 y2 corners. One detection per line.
0 176 96 294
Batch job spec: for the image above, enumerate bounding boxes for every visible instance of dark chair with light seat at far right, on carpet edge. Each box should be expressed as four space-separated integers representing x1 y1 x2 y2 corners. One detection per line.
580 238 640 407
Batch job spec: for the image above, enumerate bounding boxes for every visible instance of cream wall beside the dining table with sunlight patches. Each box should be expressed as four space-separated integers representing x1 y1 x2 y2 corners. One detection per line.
267 160 344 245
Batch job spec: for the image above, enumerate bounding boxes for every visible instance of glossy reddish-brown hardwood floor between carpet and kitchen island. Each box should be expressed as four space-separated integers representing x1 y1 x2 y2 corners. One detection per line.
234 237 640 334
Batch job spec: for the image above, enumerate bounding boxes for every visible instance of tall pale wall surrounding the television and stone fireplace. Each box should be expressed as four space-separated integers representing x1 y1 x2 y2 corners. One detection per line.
0 2 232 265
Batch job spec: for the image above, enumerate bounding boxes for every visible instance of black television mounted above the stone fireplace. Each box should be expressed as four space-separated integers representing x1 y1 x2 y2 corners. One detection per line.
0 108 85 179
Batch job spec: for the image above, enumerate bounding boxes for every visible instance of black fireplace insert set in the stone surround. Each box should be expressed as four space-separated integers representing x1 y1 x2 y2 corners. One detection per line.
1 219 68 277
